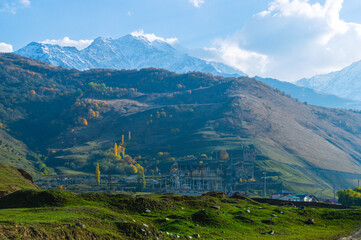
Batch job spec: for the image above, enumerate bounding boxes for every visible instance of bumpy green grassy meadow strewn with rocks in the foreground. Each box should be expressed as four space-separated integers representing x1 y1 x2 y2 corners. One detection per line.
0 190 361 239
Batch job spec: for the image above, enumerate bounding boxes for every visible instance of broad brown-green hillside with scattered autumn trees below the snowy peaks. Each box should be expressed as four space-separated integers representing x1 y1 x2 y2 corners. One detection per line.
0 54 361 196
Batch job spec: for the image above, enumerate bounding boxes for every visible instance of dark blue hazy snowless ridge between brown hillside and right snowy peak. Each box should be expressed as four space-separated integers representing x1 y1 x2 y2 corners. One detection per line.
256 77 361 109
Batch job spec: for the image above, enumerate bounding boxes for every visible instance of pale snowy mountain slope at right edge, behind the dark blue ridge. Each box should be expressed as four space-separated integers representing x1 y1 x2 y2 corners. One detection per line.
297 61 361 101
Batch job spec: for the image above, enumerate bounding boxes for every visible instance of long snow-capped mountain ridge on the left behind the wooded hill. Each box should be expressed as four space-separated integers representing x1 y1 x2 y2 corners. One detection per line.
15 35 245 76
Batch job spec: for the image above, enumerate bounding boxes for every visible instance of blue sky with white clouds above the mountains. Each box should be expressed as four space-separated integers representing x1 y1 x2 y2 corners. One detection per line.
0 0 361 81
